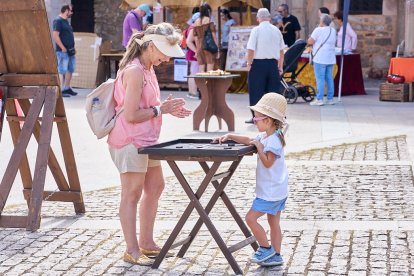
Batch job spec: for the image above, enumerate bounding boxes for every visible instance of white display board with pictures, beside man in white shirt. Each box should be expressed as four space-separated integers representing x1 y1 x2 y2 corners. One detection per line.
226 26 254 71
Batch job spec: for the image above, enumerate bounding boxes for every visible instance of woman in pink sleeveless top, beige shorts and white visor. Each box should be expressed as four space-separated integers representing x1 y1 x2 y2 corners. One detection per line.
108 23 191 265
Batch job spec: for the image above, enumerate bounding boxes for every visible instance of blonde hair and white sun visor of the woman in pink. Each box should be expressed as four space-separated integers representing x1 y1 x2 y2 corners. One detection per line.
119 23 181 69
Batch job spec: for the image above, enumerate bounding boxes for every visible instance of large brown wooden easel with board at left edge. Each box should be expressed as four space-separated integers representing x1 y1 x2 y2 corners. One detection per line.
0 0 85 231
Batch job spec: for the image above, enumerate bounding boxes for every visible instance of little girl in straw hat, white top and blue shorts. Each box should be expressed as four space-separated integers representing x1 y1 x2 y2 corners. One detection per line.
213 92 288 266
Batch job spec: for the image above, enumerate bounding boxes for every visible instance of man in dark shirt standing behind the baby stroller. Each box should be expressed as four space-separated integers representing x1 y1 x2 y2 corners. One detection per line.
277 4 301 47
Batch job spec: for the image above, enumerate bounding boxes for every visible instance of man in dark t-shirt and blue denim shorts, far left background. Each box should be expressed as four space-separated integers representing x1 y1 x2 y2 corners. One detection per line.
53 5 78 97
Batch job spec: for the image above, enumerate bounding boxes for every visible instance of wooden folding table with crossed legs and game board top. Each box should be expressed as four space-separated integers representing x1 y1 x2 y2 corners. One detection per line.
138 139 258 274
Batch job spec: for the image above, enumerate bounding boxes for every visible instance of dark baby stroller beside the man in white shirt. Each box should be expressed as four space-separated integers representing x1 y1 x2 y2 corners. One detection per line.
281 39 315 104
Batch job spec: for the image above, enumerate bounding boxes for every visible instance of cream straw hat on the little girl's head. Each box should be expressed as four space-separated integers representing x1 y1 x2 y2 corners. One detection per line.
250 92 287 123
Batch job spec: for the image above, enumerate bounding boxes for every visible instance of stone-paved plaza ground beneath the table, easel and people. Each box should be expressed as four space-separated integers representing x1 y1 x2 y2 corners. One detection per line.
0 80 414 275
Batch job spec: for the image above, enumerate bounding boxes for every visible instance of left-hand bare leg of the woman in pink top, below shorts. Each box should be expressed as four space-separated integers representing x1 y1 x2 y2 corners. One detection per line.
119 172 145 258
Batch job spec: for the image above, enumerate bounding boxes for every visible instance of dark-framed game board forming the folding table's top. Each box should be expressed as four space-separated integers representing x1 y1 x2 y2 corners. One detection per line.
138 139 256 157
